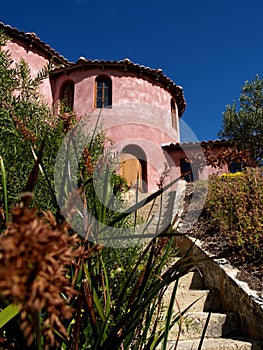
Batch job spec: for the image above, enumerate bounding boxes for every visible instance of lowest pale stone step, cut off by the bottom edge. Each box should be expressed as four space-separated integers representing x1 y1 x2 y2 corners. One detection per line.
167 338 263 350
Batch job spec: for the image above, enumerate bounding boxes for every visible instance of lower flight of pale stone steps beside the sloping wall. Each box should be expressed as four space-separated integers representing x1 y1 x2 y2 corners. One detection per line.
162 262 263 350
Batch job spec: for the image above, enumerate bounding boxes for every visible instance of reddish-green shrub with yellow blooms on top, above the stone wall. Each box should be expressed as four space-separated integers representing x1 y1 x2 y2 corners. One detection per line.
205 169 263 260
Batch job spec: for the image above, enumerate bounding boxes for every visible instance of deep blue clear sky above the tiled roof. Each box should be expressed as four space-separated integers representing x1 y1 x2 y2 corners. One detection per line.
0 0 263 141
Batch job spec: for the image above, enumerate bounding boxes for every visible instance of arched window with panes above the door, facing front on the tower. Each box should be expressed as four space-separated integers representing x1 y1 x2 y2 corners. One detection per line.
95 76 112 108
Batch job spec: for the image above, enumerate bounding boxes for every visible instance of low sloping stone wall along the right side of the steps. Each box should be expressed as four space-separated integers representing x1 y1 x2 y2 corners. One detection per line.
176 236 263 340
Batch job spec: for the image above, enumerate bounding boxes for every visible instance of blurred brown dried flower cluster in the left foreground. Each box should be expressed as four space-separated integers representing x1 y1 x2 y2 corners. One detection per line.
0 207 83 348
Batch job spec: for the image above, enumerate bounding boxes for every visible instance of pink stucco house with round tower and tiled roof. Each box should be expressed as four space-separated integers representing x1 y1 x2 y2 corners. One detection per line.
0 23 228 192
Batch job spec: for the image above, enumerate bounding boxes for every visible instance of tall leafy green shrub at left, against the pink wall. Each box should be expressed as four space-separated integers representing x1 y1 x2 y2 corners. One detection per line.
0 32 64 217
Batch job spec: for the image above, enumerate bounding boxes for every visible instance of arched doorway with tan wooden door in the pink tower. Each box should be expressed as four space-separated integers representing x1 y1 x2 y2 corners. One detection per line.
120 145 148 192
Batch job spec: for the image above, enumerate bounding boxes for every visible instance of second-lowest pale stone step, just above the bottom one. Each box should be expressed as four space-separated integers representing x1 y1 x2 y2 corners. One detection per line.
169 312 239 340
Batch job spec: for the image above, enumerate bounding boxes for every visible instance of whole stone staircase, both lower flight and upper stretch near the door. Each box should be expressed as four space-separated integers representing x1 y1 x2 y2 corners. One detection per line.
127 183 263 350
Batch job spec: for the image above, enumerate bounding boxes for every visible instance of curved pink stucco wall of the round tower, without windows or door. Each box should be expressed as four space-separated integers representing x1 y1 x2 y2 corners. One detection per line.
54 68 182 192
